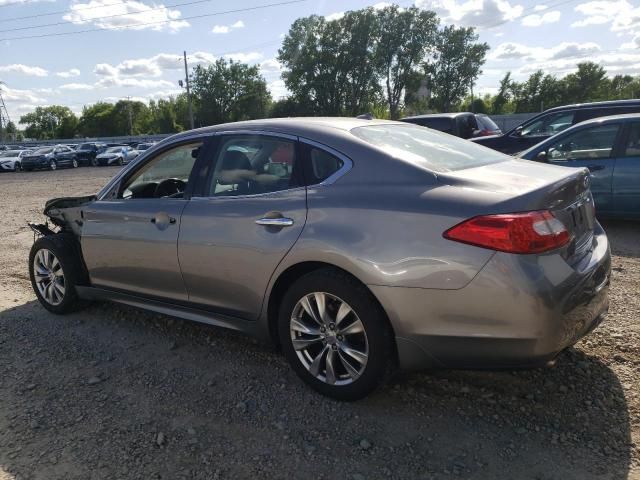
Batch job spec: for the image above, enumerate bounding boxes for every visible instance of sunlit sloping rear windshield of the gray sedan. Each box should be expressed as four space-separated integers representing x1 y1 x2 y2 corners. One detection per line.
351 124 511 172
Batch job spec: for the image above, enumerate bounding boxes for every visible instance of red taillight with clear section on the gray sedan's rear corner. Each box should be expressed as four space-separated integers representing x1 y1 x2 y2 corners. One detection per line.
443 210 571 254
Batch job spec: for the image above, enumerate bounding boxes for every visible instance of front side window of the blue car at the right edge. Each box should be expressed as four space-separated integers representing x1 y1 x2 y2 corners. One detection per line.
547 125 619 162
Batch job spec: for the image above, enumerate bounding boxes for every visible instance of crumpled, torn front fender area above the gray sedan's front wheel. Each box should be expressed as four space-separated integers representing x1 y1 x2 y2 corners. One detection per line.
28 195 96 238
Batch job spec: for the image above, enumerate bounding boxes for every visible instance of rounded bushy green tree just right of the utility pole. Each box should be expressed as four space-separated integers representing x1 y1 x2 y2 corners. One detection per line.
191 59 271 125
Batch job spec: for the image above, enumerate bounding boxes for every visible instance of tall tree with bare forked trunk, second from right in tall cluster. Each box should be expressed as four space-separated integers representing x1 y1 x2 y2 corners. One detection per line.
374 5 438 119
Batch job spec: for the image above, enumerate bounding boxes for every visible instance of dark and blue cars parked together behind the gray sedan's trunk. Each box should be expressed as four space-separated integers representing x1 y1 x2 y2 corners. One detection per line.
402 100 640 219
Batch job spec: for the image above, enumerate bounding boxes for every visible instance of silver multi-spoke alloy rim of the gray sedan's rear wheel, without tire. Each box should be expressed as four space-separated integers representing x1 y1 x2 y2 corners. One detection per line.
289 292 369 385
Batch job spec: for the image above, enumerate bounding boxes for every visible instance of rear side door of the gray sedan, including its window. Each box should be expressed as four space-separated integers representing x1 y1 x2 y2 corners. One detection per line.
178 132 307 320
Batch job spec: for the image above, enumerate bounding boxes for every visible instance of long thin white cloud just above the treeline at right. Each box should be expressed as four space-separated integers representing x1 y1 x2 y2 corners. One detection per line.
488 42 601 64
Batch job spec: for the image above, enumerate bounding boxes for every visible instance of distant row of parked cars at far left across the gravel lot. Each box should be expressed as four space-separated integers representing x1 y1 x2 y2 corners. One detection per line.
0 142 153 172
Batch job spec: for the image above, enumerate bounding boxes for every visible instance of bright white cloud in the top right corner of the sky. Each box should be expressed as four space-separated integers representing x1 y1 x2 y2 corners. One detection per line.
571 0 640 32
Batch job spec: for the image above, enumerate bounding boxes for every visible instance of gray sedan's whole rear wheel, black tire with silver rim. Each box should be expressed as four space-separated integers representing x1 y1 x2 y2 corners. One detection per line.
278 268 396 401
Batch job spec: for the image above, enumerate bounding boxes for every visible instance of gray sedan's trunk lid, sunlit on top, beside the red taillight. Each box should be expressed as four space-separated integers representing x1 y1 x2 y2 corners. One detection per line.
438 159 596 263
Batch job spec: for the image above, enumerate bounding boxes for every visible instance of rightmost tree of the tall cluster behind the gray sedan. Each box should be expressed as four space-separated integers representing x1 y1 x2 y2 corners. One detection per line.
426 25 489 112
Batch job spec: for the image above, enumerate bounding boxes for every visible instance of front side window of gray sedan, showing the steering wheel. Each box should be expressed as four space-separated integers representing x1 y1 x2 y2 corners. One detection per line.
119 142 202 199
